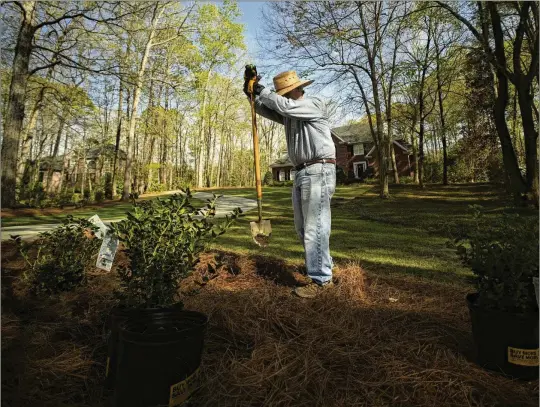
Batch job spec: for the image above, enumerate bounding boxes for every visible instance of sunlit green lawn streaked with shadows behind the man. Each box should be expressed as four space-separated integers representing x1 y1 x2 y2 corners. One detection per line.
206 184 538 283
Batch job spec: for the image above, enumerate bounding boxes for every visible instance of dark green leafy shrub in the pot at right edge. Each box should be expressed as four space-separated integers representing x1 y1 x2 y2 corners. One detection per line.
456 205 538 312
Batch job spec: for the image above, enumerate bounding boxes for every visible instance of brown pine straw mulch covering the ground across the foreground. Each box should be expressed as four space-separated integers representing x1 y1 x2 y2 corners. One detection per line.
2 244 538 407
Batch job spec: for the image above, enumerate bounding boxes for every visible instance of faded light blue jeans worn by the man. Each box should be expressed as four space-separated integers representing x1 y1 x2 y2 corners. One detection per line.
292 164 336 284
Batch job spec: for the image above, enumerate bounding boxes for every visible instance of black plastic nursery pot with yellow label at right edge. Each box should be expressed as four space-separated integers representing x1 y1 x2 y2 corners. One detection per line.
467 293 539 380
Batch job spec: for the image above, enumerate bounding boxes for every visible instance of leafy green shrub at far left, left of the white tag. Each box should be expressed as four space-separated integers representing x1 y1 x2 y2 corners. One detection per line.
11 215 101 294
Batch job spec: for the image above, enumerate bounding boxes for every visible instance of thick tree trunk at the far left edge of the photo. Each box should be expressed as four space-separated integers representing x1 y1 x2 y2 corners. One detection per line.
0 1 36 208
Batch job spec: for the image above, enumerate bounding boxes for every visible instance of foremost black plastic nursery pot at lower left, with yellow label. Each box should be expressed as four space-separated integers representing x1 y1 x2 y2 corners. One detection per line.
114 311 208 407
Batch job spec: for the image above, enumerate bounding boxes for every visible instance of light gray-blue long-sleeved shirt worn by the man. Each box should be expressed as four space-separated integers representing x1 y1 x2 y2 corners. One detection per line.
255 88 336 165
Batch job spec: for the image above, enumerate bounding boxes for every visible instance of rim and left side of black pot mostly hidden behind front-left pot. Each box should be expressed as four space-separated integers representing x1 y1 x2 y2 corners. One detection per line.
105 303 183 389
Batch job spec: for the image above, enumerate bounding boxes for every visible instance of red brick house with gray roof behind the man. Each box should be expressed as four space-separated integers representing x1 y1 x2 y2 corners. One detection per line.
270 123 414 181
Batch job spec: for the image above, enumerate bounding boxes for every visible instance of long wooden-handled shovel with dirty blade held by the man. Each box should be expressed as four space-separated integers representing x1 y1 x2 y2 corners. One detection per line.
248 78 272 247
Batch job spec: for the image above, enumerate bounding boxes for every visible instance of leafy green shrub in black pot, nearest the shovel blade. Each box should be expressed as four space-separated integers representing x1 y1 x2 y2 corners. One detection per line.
111 189 241 308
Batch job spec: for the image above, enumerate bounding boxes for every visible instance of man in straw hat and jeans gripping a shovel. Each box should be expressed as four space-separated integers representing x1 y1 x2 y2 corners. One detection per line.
244 65 336 298
